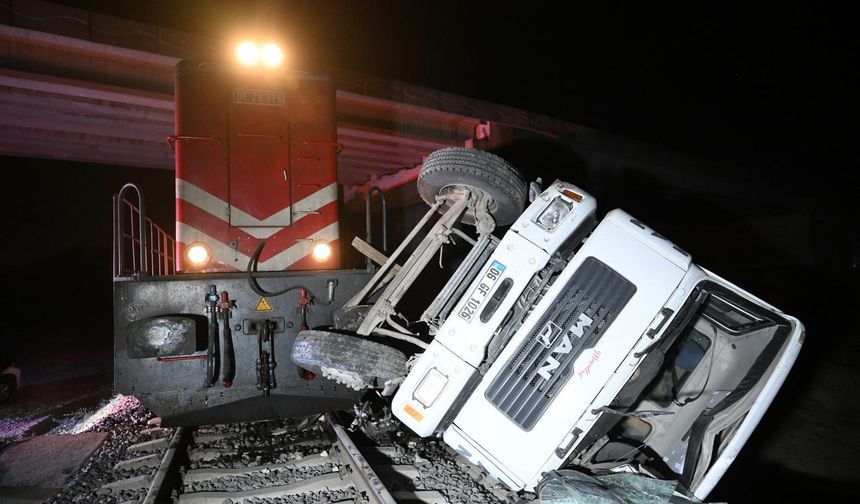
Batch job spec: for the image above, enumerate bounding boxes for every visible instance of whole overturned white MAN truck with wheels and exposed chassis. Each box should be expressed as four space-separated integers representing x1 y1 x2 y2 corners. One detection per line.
292 148 804 499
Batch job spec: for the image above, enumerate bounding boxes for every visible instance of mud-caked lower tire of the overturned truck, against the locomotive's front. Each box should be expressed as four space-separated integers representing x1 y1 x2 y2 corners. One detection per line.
291 330 406 390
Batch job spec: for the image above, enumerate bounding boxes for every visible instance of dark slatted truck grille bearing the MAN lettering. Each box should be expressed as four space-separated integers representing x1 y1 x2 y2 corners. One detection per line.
485 257 636 430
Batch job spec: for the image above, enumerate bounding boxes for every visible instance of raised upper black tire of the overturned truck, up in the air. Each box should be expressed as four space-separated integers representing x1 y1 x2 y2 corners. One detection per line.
418 147 528 226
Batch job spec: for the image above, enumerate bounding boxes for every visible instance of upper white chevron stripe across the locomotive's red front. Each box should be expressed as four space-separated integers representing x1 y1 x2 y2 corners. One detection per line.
176 178 337 238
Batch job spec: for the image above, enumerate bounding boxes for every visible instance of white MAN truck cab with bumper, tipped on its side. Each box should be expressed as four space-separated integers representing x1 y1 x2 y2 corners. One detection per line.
392 182 803 498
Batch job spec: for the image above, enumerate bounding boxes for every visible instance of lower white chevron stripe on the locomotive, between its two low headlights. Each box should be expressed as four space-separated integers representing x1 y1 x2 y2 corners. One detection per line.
177 222 338 271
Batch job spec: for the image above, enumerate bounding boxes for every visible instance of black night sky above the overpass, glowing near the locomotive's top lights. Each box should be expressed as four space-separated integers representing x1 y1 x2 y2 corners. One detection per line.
52 0 858 173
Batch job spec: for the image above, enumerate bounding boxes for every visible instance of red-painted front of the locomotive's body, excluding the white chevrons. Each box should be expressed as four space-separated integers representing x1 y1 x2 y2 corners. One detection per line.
175 61 339 271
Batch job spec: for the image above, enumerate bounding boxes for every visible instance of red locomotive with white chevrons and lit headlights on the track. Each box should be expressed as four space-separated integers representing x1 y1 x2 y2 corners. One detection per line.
114 46 368 424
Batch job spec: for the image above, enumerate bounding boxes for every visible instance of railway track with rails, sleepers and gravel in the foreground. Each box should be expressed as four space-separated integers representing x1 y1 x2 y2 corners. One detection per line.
87 408 515 504
